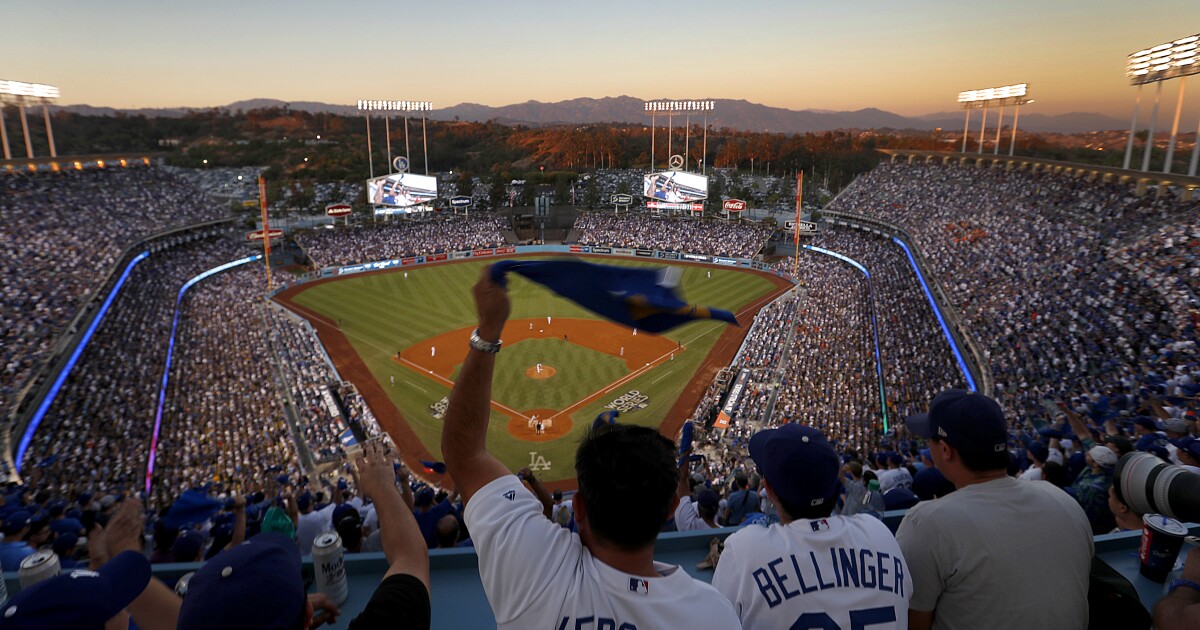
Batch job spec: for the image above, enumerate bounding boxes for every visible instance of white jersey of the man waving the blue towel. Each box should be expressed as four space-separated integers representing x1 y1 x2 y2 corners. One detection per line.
463 475 738 630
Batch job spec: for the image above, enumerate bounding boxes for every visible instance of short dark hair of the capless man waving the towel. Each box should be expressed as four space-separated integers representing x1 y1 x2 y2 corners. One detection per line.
575 425 679 551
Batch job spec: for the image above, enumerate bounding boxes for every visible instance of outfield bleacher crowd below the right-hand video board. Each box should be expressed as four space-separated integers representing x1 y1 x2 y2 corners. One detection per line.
572 212 770 258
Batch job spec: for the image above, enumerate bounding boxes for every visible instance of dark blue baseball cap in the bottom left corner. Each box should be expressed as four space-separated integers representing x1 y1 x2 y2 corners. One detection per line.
0 551 150 630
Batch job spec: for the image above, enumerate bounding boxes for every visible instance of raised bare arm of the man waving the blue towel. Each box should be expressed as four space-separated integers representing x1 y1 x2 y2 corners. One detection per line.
442 266 511 503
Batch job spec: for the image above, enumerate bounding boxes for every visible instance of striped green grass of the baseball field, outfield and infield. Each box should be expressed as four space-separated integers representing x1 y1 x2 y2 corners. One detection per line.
294 257 773 480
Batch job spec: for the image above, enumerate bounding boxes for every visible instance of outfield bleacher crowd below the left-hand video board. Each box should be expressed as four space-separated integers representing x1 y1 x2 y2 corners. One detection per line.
296 214 510 266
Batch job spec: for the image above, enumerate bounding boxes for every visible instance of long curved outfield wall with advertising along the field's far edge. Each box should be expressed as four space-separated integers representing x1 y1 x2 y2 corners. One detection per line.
278 245 797 296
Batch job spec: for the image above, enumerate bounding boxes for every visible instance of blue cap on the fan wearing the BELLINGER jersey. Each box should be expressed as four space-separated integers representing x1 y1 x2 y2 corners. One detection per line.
750 424 841 506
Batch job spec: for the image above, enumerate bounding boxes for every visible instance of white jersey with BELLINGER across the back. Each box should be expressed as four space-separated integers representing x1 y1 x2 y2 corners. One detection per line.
713 515 912 630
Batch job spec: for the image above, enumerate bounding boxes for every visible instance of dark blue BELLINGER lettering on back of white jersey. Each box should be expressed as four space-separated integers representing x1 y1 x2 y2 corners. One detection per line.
750 547 907 607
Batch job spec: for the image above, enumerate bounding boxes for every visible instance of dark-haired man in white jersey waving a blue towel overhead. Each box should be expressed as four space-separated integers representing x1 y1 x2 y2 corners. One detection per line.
442 269 738 630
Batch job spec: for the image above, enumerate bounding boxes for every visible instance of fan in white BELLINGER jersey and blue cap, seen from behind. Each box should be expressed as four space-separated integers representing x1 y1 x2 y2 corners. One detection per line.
713 424 912 630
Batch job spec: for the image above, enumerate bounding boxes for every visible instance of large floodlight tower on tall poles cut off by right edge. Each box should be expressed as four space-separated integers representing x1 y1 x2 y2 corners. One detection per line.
1124 34 1200 176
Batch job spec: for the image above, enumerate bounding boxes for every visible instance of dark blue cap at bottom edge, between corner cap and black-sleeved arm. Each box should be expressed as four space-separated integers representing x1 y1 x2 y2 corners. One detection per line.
175 534 305 630
